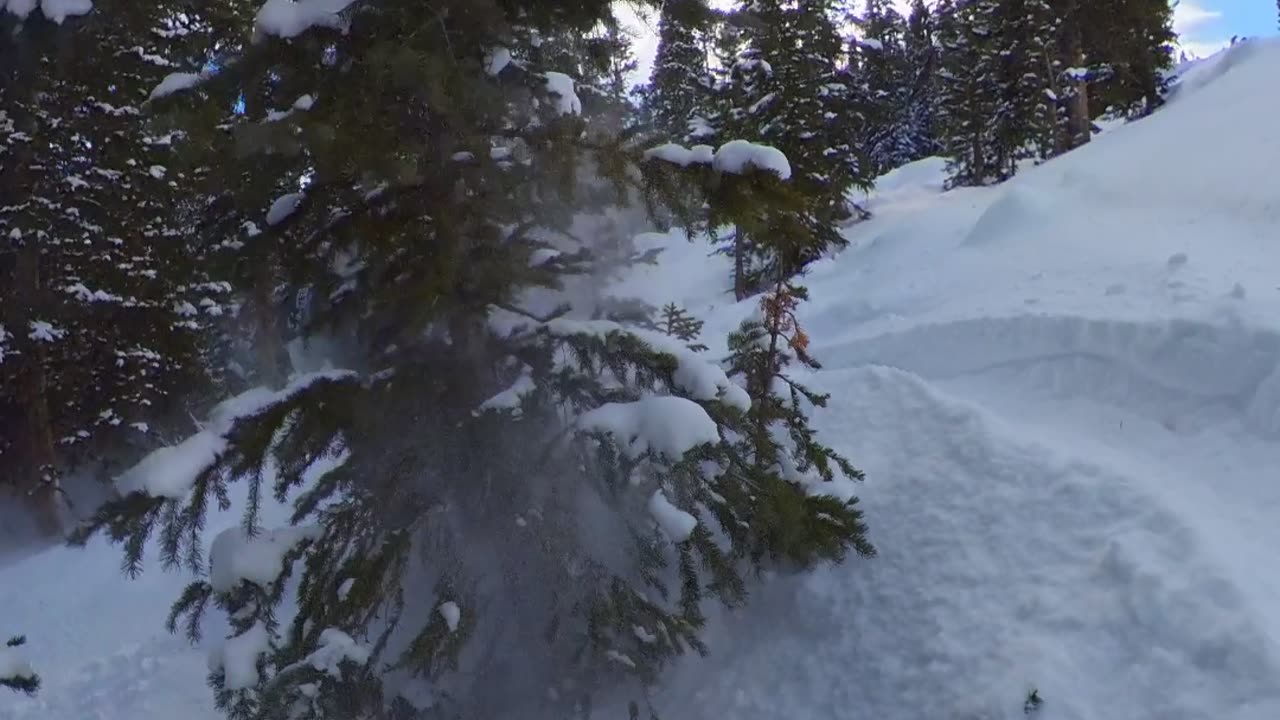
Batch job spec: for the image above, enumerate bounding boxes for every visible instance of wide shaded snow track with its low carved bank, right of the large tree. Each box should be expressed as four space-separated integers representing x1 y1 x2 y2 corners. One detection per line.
650 316 1280 720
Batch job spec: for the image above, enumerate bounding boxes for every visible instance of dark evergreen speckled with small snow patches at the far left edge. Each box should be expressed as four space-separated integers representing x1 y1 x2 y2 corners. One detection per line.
0 4 218 532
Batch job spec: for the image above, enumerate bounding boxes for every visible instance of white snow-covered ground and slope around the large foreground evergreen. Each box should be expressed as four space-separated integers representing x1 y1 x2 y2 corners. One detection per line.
0 41 1280 720
